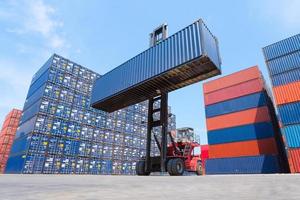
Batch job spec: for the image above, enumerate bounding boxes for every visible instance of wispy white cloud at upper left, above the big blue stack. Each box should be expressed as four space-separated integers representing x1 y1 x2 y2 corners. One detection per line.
0 0 70 51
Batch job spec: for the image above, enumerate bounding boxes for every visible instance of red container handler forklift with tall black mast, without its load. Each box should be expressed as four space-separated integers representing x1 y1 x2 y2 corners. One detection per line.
136 24 202 176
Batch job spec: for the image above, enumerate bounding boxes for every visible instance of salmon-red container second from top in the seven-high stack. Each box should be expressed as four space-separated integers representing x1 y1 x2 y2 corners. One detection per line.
204 78 264 106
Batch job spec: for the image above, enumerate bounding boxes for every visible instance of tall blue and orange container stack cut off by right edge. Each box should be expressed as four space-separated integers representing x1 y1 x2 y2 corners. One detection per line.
263 34 300 173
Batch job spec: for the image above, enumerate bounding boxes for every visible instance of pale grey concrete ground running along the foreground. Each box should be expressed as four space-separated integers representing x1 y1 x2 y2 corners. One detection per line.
0 174 300 200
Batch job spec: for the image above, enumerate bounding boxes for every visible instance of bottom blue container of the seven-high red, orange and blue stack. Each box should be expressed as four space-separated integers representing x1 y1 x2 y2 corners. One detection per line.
206 156 280 174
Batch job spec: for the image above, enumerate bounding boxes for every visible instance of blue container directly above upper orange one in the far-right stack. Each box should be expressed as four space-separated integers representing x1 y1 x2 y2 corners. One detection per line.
271 68 300 86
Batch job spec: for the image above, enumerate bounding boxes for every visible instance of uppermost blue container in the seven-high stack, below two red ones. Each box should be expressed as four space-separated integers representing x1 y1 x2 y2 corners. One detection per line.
205 92 267 118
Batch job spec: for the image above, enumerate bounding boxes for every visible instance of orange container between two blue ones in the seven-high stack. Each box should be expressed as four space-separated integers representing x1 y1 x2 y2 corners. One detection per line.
206 106 271 131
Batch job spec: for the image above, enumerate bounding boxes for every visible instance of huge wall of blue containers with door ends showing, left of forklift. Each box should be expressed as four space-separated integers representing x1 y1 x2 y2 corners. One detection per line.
6 54 172 175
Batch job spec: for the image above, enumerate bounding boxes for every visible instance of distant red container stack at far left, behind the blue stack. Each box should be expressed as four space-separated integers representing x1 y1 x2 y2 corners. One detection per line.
0 109 22 173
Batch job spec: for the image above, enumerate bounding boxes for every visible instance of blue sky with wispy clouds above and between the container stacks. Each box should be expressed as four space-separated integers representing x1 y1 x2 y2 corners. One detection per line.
0 0 300 143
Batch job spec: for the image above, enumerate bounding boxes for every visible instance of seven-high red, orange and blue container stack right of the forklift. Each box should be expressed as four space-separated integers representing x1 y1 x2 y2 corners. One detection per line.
203 66 284 174
